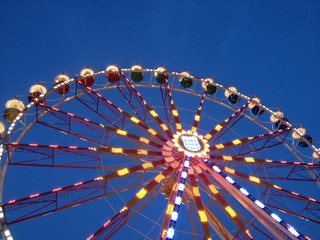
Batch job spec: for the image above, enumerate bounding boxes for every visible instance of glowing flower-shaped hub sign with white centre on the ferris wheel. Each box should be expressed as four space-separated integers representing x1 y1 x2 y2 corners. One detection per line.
173 130 209 157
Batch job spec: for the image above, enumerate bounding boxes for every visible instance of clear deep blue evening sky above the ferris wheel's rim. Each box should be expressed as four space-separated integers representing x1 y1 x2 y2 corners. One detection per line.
0 0 320 240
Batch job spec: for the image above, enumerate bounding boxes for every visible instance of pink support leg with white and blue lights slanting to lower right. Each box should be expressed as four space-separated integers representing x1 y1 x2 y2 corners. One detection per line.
203 160 307 239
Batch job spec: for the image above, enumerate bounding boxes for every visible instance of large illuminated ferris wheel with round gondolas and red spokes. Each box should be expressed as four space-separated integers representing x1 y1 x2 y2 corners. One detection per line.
0 65 320 240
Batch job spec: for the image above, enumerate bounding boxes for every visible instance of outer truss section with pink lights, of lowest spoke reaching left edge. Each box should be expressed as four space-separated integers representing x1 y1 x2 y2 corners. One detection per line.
2 178 107 224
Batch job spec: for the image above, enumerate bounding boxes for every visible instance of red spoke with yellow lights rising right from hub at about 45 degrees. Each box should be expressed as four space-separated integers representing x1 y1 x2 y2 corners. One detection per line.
204 102 249 145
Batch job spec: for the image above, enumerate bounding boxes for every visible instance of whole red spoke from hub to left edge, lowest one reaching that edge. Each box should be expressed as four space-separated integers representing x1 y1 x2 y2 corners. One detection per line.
2 159 166 224
